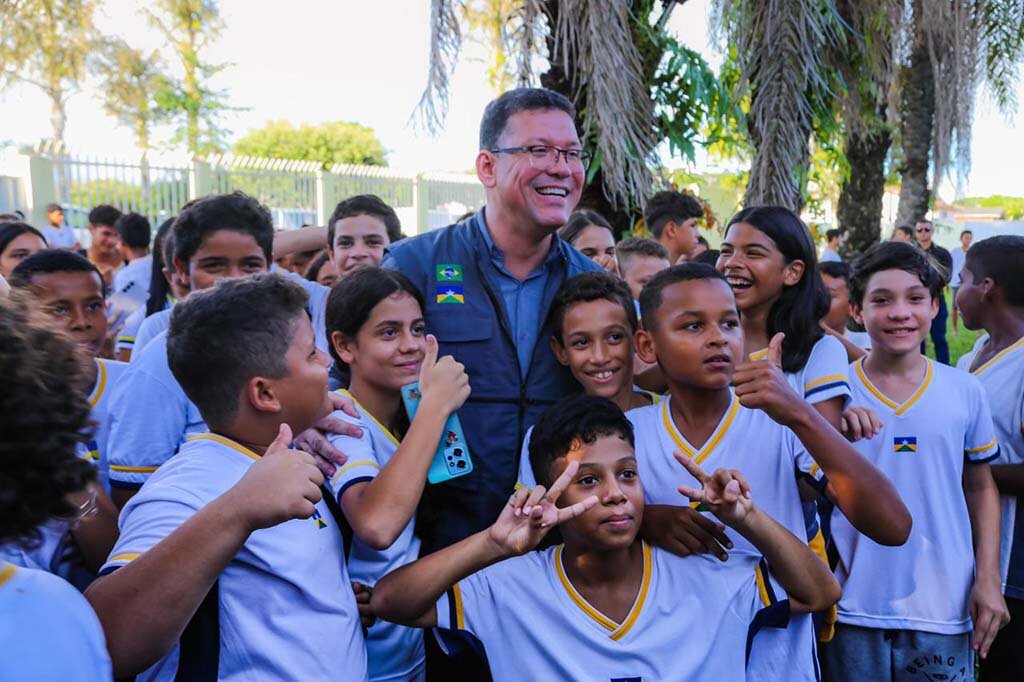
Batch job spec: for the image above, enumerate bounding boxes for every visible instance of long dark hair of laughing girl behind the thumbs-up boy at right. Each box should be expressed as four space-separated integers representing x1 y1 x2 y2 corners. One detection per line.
725 206 829 372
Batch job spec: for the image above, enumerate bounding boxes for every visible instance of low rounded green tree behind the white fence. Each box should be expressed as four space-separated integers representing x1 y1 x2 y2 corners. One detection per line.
231 121 387 170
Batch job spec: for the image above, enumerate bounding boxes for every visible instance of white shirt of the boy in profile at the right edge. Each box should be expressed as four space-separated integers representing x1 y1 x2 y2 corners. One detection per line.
956 334 1024 599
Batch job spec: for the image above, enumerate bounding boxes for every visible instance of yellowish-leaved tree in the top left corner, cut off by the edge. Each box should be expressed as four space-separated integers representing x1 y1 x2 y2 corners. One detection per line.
0 0 96 148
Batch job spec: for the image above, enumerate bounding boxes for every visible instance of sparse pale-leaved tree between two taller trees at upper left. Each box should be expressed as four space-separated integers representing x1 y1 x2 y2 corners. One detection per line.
92 39 170 152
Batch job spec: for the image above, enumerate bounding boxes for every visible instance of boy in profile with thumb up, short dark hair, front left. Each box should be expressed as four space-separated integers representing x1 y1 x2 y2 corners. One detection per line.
86 274 367 680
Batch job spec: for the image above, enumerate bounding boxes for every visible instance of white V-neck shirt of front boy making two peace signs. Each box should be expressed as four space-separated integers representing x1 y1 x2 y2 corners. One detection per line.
436 544 788 682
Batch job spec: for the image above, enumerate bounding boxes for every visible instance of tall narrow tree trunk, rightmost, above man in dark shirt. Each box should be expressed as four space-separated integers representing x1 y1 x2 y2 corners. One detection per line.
896 0 935 225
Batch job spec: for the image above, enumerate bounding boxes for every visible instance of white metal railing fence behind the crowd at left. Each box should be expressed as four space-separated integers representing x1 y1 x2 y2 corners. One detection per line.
0 147 484 235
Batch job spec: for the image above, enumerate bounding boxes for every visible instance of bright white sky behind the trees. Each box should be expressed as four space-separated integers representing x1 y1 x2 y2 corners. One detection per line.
0 0 1024 197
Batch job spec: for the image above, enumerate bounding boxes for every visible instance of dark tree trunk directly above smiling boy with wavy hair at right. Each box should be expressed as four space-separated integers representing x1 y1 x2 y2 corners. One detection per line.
837 127 892 260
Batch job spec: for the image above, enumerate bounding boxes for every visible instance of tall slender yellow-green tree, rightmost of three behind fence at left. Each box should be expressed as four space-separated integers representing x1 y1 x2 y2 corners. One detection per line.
142 0 231 155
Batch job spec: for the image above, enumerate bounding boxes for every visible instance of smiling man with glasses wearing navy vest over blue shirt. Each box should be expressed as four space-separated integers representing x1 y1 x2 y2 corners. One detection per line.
382 88 600 554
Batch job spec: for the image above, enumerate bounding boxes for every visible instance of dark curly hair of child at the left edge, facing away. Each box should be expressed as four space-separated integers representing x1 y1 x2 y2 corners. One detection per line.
0 292 96 545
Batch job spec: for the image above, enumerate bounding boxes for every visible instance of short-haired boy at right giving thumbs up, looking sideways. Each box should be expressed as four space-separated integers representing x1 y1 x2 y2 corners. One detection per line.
627 263 910 680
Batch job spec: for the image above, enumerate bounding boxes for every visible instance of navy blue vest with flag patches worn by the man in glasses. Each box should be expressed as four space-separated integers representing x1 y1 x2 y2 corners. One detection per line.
385 211 600 554
